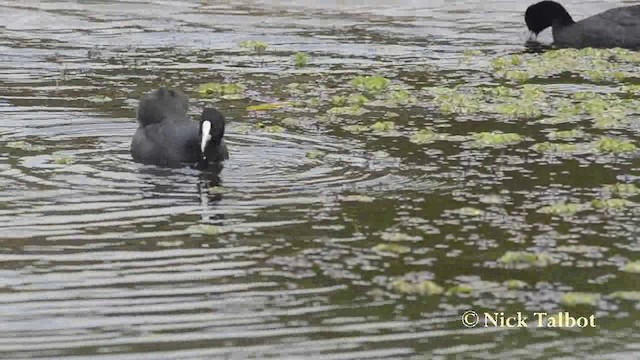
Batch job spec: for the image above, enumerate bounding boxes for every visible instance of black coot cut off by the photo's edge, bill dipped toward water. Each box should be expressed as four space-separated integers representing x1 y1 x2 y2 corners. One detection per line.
524 1 640 49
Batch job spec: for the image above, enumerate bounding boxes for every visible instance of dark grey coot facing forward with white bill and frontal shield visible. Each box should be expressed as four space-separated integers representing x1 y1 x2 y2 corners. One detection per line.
131 87 229 168
